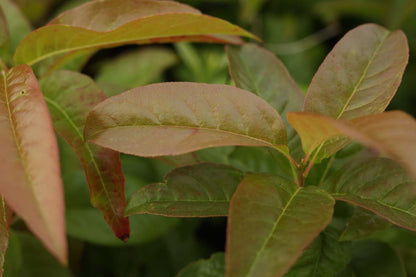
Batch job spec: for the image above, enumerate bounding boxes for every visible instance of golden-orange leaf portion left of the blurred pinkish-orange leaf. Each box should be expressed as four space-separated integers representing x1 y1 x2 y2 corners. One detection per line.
287 112 349 163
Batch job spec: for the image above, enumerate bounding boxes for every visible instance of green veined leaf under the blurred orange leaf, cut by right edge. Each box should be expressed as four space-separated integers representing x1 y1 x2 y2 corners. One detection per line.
323 158 416 230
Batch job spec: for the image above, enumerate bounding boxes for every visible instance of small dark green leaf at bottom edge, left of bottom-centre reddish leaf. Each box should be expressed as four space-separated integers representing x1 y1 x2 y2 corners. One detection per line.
175 253 225 277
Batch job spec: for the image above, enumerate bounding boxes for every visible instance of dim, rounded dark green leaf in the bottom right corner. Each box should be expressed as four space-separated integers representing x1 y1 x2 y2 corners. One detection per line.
351 238 407 277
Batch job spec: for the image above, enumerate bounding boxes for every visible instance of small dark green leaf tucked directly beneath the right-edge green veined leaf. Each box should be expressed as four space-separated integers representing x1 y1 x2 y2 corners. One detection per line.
339 207 391 241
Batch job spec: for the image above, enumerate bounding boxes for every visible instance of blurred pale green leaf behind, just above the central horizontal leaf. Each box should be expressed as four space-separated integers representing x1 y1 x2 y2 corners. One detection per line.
95 47 177 96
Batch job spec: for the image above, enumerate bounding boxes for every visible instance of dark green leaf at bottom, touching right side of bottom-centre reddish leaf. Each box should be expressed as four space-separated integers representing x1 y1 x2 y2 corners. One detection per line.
285 227 351 277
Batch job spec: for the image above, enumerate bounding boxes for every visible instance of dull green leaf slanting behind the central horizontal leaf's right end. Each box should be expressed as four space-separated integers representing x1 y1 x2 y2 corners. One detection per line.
227 44 304 160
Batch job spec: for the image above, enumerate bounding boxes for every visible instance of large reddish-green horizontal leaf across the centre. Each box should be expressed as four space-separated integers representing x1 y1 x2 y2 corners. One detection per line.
84 83 287 157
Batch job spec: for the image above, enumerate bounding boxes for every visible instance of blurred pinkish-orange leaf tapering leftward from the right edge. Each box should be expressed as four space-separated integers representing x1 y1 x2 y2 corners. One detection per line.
331 111 416 181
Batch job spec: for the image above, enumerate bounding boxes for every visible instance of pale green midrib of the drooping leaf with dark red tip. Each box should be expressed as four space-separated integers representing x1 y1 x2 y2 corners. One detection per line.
44 96 119 217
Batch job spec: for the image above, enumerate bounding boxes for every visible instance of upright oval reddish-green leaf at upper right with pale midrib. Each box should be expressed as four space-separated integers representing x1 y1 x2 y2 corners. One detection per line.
304 24 409 119
